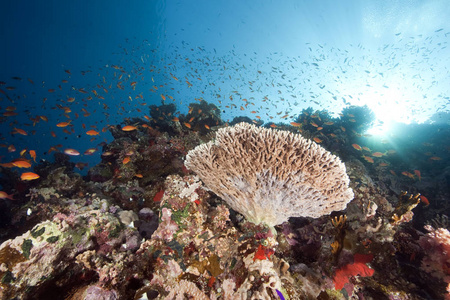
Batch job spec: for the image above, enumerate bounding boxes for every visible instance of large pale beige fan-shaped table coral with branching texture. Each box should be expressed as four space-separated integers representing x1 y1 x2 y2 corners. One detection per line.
185 123 353 227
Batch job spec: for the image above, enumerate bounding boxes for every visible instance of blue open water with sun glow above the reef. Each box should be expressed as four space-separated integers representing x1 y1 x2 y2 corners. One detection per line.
0 1 450 176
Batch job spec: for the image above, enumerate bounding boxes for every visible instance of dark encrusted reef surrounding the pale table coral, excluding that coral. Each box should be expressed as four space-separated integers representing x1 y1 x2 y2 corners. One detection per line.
0 101 450 299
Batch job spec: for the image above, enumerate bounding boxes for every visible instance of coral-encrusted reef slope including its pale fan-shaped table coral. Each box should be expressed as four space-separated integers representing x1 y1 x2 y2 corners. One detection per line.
0 105 450 300
